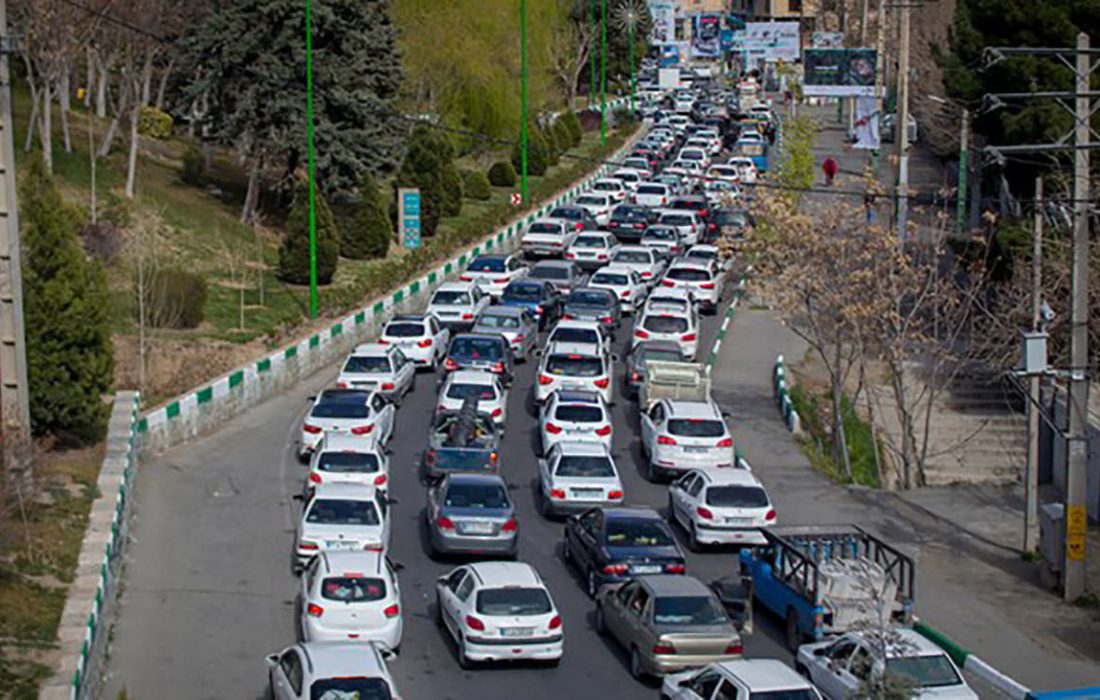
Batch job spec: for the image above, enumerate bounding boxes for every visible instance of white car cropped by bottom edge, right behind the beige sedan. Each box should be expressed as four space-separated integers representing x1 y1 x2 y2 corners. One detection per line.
661 658 821 700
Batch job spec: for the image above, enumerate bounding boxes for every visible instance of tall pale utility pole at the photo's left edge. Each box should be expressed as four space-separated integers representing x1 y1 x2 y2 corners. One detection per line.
0 0 32 480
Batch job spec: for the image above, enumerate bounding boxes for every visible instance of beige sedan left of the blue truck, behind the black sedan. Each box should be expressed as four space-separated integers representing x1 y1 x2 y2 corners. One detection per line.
596 575 741 679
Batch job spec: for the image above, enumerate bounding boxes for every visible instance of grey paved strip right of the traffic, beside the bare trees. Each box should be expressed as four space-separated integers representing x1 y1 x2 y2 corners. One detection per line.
714 305 1100 694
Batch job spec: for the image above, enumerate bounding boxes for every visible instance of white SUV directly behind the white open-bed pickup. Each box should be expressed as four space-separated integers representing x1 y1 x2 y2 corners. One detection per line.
639 398 736 477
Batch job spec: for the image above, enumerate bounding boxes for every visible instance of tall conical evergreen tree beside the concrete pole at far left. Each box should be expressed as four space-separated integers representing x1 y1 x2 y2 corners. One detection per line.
20 157 114 441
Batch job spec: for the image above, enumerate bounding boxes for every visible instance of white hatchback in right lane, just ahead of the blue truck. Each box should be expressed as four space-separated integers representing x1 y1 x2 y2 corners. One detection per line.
669 466 776 549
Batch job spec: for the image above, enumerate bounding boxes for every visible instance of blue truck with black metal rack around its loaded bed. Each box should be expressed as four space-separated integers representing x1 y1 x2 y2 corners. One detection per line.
740 525 916 650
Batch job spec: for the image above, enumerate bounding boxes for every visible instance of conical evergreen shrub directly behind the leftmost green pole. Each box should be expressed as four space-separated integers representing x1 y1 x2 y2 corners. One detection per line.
278 181 340 284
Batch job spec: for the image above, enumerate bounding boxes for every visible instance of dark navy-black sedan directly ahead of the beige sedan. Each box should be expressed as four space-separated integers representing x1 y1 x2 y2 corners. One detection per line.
561 507 688 598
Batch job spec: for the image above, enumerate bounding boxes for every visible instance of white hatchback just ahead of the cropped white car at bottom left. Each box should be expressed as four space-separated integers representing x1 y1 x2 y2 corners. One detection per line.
298 550 405 652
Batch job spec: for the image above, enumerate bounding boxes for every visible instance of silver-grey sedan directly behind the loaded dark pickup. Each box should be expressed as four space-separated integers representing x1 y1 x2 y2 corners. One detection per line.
427 474 519 558
